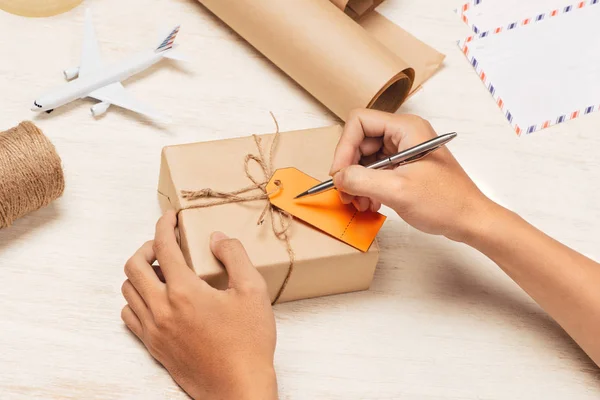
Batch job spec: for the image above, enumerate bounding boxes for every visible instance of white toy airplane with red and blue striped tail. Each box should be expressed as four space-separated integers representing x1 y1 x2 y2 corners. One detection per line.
31 10 181 120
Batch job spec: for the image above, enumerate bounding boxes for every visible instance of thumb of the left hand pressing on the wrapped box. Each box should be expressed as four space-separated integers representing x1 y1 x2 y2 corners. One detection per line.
210 232 262 288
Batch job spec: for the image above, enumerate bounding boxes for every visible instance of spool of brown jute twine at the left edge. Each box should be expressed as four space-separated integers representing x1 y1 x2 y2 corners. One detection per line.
0 122 65 229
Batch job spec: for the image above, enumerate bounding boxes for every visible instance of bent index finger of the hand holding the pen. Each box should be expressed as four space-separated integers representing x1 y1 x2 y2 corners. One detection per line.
330 109 393 175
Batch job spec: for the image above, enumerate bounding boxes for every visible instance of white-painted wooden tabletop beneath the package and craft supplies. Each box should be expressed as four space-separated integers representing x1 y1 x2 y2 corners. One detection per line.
0 0 600 400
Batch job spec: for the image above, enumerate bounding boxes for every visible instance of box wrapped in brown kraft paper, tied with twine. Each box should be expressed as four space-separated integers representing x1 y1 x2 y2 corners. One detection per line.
158 126 379 302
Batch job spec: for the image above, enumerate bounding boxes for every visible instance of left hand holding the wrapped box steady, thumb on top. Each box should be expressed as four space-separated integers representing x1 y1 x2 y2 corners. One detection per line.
121 212 277 400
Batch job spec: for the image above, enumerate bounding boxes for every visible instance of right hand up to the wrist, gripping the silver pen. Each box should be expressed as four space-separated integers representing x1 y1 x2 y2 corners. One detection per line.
331 110 493 241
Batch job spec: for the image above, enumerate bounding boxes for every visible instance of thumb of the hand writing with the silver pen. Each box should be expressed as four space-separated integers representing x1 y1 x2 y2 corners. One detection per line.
333 165 399 206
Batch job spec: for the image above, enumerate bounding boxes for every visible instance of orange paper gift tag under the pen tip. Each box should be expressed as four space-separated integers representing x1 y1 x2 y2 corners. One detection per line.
267 168 385 251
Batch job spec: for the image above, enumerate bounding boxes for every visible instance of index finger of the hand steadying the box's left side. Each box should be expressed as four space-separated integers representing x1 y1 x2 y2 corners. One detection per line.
153 211 193 284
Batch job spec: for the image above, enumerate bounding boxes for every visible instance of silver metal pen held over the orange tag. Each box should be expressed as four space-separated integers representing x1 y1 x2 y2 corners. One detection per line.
295 132 457 199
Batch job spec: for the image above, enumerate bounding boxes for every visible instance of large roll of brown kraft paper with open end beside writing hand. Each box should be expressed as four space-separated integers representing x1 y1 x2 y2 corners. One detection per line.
199 0 414 120
